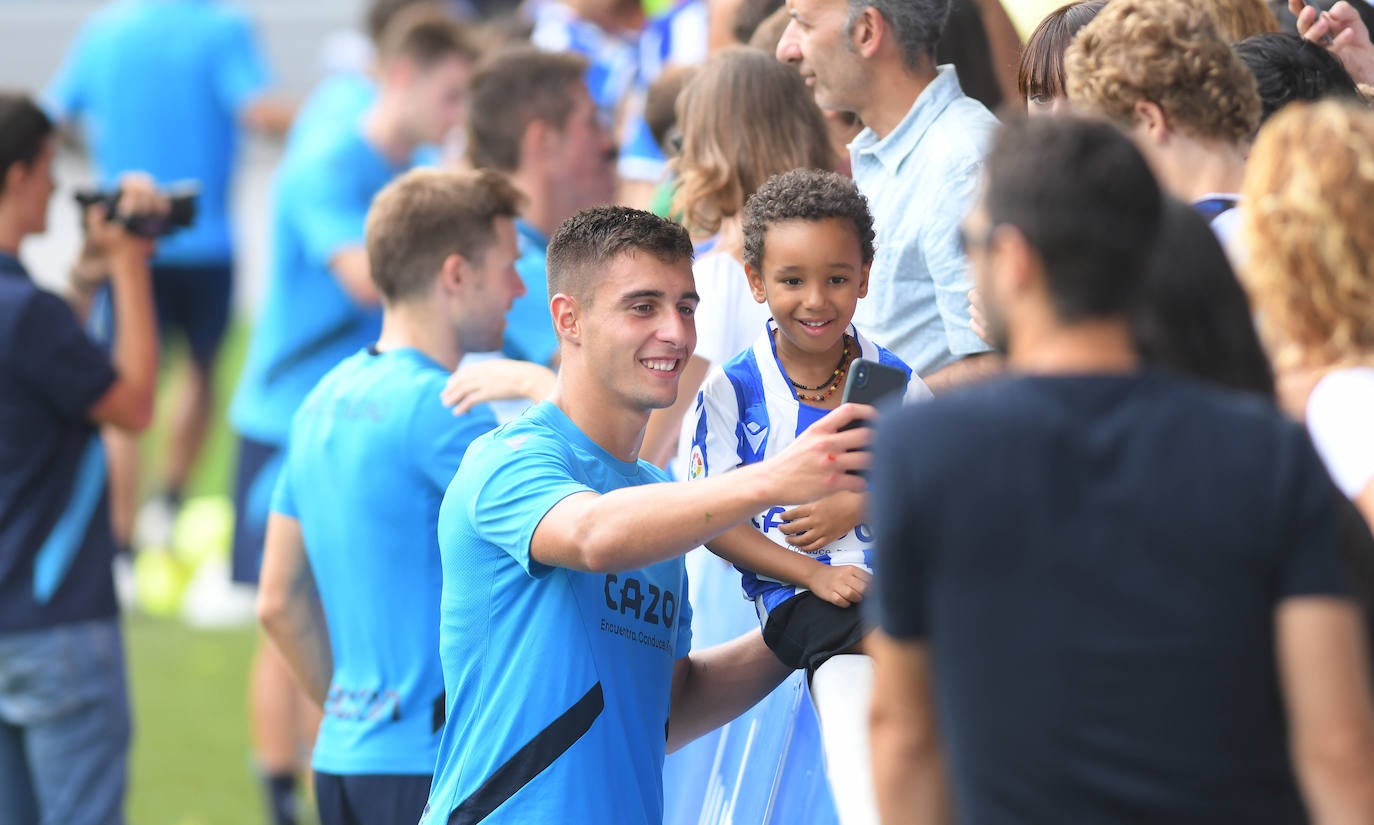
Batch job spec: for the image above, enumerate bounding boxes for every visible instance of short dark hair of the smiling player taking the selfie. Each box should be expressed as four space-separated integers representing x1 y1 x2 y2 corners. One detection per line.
547 206 692 304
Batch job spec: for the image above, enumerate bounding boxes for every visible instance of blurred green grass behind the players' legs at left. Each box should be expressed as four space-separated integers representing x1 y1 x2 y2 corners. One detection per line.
125 322 313 825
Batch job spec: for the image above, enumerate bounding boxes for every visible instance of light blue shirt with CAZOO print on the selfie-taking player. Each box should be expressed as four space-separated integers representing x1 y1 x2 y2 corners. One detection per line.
422 402 691 825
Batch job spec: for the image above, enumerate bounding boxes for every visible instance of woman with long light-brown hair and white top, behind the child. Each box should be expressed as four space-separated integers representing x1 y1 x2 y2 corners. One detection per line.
640 47 835 474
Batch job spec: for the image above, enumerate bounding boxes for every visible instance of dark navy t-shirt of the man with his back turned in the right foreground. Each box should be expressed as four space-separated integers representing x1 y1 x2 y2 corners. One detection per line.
872 373 1345 825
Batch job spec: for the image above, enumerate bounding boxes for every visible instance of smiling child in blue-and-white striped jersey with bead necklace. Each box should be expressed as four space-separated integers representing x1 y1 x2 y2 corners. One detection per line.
690 169 930 824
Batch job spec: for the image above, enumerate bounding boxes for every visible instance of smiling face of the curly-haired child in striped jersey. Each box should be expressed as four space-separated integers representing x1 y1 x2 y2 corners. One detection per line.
747 217 868 356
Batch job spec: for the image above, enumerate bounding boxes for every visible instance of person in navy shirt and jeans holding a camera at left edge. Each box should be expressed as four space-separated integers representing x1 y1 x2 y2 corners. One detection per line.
0 94 166 825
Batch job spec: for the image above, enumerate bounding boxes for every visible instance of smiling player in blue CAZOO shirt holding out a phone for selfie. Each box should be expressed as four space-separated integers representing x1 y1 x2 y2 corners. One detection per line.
422 206 871 825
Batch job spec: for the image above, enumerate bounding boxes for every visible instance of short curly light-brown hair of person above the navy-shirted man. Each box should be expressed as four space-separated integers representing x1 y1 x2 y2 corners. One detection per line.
1063 0 1260 143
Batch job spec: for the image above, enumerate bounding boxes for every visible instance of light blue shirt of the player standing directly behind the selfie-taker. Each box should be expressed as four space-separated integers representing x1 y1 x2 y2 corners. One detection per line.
272 349 496 776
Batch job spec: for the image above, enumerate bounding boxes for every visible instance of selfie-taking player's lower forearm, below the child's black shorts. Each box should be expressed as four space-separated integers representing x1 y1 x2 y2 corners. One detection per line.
668 630 791 754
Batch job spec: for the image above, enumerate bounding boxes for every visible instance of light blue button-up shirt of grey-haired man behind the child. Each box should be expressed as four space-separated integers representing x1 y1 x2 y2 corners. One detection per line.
849 66 998 375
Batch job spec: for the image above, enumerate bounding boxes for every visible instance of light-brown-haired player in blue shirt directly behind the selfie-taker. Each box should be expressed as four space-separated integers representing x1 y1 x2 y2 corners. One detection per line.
258 169 523 825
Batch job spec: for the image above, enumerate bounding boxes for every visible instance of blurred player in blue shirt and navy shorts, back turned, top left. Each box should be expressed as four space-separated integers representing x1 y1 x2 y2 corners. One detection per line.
45 0 291 545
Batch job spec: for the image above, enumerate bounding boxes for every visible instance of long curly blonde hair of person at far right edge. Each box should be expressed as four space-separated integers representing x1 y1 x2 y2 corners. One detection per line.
1241 100 1374 369
